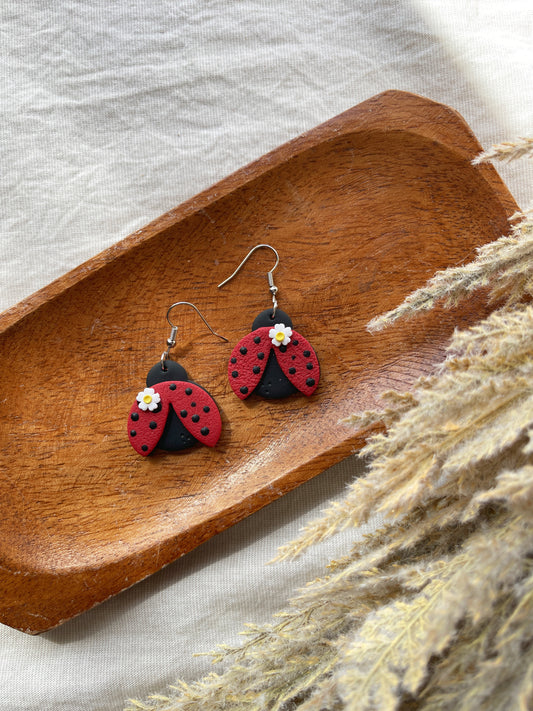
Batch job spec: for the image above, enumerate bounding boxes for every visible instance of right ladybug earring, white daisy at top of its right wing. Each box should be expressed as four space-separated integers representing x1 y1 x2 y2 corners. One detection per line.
218 244 320 400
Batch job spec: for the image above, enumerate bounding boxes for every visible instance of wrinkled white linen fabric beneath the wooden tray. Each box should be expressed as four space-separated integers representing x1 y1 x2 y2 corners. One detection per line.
0 0 533 711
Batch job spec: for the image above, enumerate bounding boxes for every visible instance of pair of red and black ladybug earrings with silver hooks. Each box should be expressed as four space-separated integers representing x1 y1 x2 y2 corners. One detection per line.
128 244 320 456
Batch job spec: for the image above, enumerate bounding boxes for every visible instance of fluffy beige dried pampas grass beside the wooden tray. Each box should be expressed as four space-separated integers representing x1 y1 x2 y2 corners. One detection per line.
128 139 533 711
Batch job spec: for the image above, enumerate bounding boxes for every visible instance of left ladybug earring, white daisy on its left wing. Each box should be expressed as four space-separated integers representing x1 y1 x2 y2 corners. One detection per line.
128 301 228 457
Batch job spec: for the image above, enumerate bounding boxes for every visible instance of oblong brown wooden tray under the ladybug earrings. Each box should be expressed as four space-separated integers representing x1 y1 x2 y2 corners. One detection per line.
0 91 516 633
